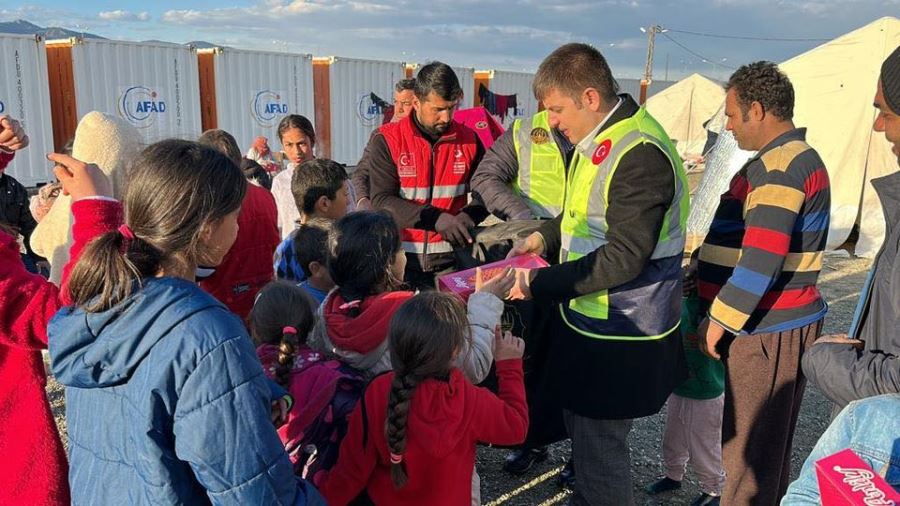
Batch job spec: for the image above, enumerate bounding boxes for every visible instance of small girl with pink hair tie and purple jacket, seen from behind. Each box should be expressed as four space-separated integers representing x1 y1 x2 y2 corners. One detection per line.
249 281 365 486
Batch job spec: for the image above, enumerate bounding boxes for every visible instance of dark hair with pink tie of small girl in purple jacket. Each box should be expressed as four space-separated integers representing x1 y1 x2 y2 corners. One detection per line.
248 281 315 386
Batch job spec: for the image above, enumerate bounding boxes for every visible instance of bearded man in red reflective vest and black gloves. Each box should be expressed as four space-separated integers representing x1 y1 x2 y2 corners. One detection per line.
357 62 488 289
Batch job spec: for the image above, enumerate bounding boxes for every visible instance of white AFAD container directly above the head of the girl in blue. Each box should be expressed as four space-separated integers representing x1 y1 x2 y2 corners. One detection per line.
60 39 201 143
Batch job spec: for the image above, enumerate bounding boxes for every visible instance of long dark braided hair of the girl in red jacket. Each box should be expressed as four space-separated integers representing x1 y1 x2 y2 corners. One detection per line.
384 292 471 488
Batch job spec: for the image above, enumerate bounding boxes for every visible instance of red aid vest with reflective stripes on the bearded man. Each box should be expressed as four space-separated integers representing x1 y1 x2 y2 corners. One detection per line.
380 114 478 254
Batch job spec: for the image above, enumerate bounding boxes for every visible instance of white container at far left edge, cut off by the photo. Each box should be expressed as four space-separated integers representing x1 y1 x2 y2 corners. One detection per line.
0 34 53 186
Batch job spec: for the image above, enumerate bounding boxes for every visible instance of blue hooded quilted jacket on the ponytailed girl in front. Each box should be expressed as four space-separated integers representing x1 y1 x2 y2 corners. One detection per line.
49 278 323 505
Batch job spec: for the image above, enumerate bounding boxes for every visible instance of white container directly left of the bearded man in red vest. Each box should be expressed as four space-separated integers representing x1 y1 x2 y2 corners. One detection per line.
328 57 406 165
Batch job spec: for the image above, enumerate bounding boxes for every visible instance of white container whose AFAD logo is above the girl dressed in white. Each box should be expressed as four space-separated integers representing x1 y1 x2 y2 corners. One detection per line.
199 48 315 154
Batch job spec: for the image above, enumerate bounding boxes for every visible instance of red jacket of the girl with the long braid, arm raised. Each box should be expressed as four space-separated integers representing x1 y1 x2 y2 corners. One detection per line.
321 360 528 506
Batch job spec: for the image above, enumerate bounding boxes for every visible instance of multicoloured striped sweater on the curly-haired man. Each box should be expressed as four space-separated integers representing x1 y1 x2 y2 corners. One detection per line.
698 128 831 334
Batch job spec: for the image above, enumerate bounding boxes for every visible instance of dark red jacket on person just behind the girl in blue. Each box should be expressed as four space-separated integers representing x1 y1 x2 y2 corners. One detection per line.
200 184 281 319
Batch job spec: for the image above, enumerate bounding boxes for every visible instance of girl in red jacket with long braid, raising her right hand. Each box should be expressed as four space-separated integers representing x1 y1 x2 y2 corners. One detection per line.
322 292 528 506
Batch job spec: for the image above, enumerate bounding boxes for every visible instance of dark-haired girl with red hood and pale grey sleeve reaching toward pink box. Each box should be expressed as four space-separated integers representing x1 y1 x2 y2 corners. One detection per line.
310 211 515 384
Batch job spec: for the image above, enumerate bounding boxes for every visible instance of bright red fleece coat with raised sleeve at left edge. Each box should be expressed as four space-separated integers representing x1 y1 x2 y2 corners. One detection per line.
0 200 122 505
